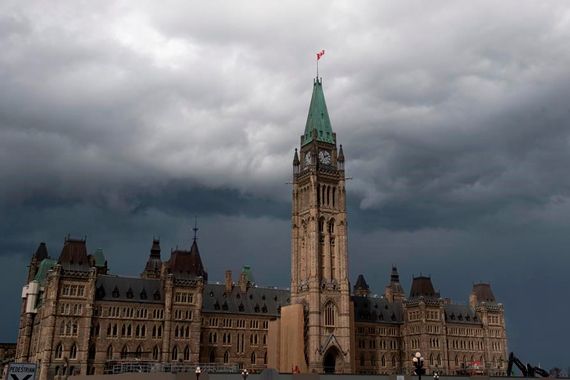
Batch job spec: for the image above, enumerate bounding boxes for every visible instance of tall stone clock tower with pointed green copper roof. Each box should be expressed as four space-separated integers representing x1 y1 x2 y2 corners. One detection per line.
291 78 354 373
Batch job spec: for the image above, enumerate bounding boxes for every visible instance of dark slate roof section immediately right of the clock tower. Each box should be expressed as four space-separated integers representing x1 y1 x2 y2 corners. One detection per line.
352 296 404 323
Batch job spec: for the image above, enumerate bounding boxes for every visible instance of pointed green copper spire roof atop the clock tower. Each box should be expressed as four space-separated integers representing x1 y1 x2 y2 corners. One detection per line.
302 78 335 145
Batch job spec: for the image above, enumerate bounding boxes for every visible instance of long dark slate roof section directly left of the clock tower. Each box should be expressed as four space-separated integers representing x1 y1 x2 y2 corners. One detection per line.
202 284 291 317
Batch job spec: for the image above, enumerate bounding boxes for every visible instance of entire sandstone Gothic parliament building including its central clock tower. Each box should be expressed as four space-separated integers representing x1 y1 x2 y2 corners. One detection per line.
16 78 507 380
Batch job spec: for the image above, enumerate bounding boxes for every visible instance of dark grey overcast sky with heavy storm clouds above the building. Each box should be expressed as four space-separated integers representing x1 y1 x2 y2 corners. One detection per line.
0 0 570 368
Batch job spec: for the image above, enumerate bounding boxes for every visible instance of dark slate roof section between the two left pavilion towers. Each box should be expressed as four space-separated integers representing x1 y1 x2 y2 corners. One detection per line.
95 275 164 303
